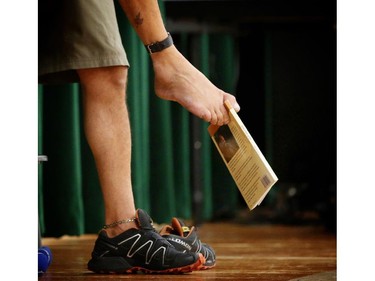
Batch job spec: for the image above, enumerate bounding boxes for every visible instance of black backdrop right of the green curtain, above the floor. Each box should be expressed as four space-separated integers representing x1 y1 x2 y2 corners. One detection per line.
164 0 337 231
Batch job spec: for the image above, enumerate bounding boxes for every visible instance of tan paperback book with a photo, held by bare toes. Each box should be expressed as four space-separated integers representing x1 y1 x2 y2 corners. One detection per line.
208 101 278 210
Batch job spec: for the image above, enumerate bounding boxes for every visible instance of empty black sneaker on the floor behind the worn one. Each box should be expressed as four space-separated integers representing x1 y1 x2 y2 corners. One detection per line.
160 218 216 270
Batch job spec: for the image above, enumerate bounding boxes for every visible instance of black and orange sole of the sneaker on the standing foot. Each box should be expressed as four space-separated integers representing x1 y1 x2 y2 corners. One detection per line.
88 254 205 274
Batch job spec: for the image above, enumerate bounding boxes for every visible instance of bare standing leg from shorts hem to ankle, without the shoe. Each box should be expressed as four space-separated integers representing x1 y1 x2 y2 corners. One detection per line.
78 66 136 237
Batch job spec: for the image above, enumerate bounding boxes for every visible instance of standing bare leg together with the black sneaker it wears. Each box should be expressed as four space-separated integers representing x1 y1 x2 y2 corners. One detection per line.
78 66 205 273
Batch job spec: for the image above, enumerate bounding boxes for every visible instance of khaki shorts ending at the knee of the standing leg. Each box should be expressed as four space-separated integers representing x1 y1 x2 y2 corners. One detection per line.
38 0 129 83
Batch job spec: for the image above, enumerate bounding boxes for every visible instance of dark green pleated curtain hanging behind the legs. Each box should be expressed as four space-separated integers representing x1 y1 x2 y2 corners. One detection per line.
38 2 238 236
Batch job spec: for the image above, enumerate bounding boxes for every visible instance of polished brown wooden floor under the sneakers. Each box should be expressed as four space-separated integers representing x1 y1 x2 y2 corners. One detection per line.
39 223 336 281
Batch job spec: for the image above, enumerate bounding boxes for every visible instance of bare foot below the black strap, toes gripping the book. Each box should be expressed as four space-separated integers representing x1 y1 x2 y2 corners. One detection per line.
151 46 240 126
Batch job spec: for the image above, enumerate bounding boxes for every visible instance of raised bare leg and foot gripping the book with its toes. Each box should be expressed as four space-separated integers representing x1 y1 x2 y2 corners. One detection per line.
119 0 240 125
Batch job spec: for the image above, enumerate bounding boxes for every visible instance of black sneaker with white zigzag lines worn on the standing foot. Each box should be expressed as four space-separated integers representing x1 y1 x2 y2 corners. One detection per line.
88 209 204 273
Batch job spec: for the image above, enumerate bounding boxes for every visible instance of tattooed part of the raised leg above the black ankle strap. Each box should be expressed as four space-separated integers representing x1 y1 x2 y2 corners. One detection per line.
119 0 167 45
